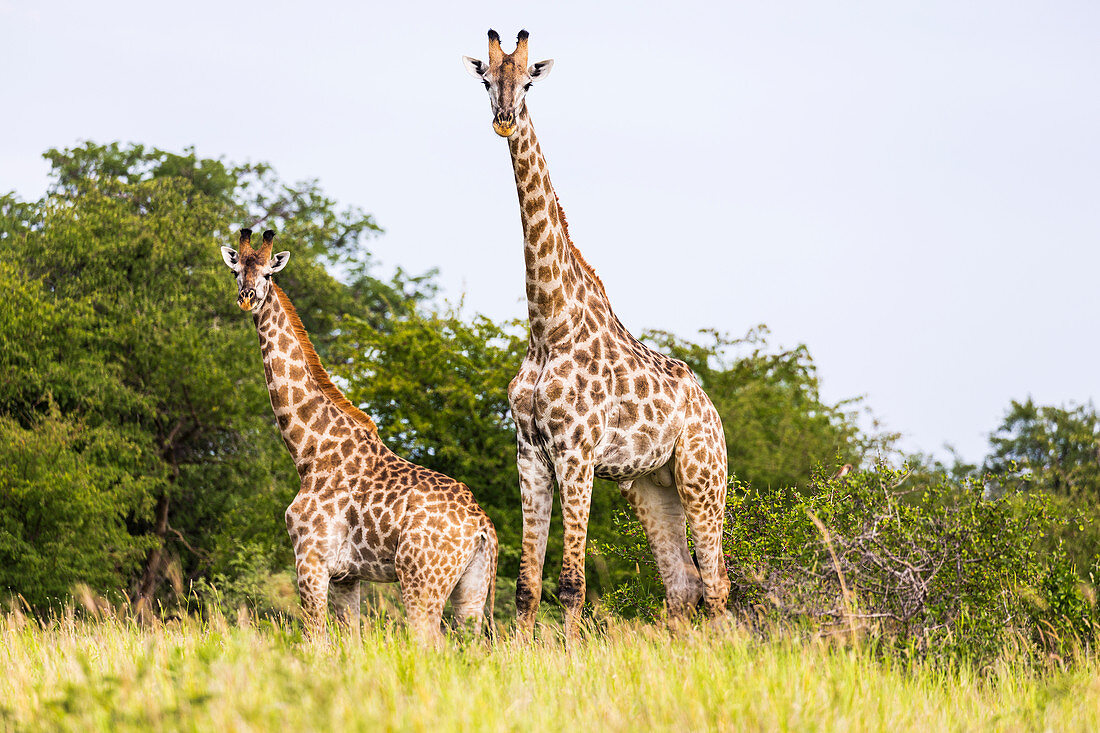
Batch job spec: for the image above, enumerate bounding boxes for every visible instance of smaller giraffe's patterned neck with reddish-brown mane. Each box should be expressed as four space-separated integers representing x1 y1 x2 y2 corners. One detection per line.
253 283 381 477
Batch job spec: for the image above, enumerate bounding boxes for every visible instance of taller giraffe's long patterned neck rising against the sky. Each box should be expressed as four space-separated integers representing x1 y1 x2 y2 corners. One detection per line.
508 103 609 343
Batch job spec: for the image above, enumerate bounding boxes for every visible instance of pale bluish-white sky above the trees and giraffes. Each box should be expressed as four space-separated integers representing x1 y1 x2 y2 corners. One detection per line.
0 0 1100 460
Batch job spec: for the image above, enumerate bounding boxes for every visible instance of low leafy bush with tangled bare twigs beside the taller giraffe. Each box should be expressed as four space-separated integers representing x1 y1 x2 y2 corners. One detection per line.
601 468 1100 658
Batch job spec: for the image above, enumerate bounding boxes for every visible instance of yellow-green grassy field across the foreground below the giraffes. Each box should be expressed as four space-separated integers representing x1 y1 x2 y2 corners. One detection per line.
0 614 1100 733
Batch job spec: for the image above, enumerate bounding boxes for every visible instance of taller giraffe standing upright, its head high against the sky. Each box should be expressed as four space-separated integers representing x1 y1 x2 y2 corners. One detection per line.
463 30 729 637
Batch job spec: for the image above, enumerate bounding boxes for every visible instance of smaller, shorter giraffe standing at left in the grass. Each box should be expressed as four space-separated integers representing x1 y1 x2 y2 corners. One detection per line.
221 229 497 643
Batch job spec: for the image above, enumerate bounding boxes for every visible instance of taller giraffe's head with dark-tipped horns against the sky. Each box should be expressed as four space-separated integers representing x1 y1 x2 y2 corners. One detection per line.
462 29 553 138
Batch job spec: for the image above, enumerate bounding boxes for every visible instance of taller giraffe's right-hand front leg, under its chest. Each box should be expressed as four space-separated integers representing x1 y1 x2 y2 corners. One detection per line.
556 452 595 643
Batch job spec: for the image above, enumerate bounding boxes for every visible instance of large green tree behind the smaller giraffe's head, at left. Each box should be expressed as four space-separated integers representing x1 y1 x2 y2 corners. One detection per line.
0 143 432 601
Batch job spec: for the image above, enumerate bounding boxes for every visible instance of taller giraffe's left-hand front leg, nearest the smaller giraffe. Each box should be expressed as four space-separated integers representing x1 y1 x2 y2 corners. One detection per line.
516 437 553 641
